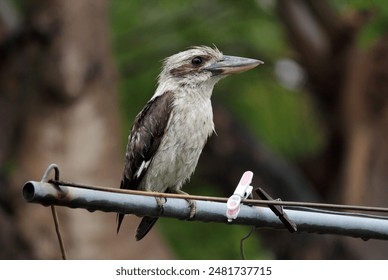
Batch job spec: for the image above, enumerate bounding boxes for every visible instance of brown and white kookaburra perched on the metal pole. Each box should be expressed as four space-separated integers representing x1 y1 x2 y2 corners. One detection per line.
117 46 262 240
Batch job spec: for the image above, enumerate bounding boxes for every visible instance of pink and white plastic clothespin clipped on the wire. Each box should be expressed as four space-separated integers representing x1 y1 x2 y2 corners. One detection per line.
226 171 253 222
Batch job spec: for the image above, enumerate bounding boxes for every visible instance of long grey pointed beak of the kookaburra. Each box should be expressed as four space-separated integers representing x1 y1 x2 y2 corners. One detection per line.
204 55 264 75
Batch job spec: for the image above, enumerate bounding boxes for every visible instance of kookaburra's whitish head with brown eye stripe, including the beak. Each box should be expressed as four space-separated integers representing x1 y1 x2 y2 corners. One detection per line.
158 46 263 97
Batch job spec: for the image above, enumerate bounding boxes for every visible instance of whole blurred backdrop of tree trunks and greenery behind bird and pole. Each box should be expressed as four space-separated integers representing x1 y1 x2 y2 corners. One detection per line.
0 0 388 259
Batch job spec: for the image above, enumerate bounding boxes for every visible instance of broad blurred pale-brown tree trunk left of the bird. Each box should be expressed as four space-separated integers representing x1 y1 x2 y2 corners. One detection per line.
1 0 172 259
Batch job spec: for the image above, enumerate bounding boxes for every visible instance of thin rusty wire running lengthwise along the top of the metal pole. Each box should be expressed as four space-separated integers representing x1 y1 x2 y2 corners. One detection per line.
48 180 388 213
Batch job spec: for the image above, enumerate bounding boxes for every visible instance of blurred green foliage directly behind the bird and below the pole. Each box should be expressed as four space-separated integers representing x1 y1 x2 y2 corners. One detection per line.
110 0 324 259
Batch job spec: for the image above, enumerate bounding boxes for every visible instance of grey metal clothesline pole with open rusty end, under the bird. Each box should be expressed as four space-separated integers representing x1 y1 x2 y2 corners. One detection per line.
23 181 388 240
